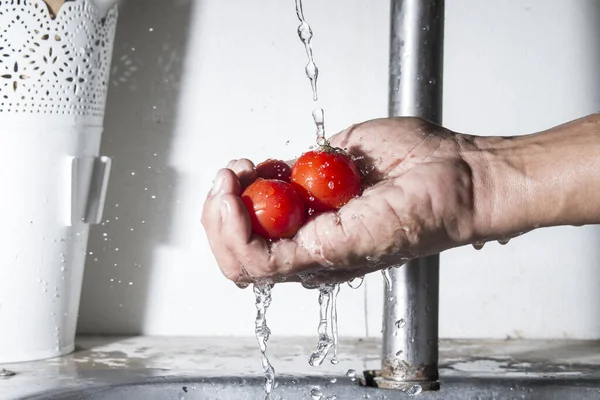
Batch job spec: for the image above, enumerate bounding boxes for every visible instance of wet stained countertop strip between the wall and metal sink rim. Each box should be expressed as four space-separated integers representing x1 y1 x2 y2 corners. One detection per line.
0 337 600 400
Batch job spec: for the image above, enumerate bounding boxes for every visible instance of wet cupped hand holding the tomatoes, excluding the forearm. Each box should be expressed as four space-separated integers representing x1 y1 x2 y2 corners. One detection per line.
202 118 476 286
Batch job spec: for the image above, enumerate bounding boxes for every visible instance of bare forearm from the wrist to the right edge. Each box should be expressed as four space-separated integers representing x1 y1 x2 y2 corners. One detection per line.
465 114 600 239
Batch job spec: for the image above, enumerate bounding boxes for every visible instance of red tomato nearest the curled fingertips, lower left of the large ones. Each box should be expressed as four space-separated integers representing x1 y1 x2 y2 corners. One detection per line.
242 178 306 240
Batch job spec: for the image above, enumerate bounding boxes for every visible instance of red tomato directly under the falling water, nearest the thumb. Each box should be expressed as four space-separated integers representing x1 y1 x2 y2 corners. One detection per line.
292 147 360 211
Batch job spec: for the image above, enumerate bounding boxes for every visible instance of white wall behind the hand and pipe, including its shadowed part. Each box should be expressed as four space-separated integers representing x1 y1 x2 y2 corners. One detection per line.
80 0 600 338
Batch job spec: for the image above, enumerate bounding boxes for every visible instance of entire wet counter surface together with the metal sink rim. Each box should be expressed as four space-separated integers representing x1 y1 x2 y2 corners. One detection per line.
0 337 600 400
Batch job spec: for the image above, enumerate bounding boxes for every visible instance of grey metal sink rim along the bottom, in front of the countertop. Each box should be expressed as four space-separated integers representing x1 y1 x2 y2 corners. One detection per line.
24 376 600 400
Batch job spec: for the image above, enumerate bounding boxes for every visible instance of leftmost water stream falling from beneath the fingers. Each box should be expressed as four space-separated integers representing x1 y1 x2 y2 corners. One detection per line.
253 283 275 400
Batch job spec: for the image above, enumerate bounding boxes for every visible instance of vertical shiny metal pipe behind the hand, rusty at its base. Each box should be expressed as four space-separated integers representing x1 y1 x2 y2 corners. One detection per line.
380 0 445 390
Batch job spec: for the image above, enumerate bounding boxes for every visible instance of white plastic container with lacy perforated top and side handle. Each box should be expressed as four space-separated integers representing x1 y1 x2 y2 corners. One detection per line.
0 0 117 364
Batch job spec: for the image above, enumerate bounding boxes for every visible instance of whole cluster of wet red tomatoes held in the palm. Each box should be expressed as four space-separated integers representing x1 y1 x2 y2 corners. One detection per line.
242 145 361 240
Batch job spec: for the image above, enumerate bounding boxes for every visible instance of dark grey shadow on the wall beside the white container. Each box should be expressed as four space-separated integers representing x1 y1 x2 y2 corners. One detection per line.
79 0 200 334
